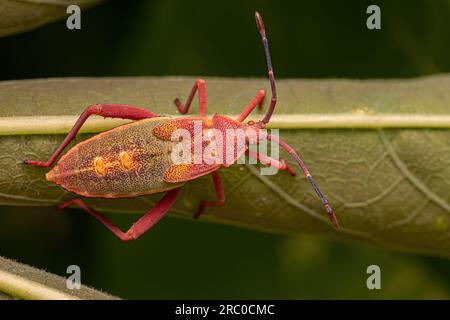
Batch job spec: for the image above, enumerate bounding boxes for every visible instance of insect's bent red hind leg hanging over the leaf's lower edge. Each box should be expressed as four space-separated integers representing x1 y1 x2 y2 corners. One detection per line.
58 188 181 242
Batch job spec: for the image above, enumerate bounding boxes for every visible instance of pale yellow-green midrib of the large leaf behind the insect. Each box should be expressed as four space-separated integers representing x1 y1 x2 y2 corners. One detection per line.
0 114 450 135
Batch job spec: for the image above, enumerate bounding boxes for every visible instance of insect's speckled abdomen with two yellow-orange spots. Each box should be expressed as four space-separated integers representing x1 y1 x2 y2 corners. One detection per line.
47 117 181 198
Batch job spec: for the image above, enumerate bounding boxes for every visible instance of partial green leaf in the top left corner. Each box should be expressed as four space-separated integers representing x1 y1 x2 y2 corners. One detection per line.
0 0 102 37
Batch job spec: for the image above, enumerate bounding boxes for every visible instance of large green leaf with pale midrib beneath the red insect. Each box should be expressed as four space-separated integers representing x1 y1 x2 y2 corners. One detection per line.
0 75 450 256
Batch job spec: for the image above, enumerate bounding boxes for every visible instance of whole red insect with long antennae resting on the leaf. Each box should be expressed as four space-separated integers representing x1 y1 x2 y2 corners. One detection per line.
24 12 339 241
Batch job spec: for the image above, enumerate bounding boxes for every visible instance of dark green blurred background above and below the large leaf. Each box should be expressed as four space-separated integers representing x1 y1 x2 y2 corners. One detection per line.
0 0 450 299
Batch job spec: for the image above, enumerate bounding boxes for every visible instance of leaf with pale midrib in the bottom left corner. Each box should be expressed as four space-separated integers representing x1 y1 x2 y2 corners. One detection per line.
0 257 118 300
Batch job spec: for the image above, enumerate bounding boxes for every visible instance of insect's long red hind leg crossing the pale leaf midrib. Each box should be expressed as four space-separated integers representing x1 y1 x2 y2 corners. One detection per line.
24 104 157 167
